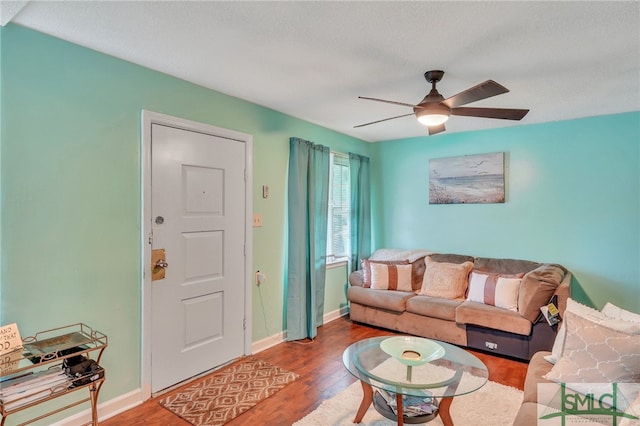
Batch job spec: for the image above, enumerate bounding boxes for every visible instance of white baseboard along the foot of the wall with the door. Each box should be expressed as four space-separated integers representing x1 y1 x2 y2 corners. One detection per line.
51 306 349 426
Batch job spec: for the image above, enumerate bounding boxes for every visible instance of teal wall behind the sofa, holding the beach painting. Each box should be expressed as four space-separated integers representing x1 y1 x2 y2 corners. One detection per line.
372 112 640 312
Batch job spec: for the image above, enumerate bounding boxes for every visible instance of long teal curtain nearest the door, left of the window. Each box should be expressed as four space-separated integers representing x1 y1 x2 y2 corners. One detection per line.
287 138 330 340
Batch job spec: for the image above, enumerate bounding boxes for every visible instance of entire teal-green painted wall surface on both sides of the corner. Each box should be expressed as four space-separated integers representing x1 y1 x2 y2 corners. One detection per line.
0 19 640 423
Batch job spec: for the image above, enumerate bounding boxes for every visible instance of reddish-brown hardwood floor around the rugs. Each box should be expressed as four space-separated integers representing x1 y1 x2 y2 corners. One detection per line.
100 317 527 426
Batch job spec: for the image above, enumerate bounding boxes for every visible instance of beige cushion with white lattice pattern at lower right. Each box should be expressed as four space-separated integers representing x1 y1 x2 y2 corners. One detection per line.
544 311 640 383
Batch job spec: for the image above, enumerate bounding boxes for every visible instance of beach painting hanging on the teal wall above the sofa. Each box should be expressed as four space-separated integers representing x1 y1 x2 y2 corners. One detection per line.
429 152 504 204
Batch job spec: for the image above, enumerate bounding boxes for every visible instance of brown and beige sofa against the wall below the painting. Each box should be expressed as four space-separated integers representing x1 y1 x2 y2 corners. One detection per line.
347 249 571 360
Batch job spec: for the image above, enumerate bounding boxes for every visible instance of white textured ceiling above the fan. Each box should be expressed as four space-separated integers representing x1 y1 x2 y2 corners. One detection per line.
6 0 640 141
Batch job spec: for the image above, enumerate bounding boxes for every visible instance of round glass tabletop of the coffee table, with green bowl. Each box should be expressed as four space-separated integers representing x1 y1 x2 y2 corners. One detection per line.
342 336 489 398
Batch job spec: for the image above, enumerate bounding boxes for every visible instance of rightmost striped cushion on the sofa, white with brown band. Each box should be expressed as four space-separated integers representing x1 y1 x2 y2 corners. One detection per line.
467 271 524 312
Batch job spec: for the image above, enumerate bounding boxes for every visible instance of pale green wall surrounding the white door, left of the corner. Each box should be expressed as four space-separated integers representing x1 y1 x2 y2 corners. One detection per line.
0 24 371 421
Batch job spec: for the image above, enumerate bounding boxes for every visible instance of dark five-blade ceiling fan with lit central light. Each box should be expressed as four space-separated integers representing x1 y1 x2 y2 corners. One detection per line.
354 70 529 135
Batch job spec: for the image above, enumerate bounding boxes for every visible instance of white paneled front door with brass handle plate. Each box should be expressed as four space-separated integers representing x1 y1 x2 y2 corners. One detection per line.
151 124 246 392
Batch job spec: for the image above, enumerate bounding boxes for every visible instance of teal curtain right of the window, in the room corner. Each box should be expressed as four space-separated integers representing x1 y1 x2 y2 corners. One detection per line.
349 152 371 271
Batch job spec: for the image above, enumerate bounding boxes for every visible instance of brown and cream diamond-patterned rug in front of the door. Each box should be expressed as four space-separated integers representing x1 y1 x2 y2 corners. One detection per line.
159 357 299 426
